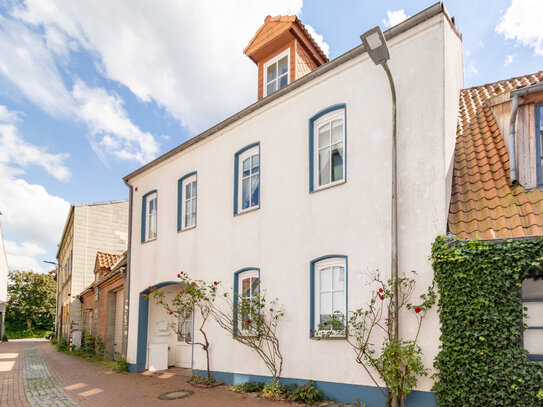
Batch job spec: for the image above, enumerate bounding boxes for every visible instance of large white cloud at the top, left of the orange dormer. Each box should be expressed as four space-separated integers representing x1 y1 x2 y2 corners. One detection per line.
15 0 303 131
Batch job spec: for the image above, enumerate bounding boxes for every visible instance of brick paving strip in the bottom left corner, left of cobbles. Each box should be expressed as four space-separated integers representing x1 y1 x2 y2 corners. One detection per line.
0 342 31 407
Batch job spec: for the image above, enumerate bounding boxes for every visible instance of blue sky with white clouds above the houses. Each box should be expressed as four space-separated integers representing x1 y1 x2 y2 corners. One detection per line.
0 0 543 272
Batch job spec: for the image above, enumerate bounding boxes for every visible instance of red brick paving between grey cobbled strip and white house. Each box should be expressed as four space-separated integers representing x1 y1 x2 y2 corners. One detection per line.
35 342 299 407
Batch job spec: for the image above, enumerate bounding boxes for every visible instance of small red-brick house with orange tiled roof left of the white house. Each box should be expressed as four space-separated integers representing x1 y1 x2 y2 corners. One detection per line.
78 251 126 360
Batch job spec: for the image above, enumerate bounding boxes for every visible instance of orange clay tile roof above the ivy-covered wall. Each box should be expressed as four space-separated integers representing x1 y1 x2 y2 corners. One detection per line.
449 71 543 239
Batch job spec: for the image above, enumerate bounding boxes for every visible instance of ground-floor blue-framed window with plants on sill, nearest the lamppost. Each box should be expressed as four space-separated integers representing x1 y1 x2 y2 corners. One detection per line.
309 254 348 338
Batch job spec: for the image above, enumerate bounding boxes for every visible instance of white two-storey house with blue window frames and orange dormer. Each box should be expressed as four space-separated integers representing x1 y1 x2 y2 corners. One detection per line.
124 3 463 407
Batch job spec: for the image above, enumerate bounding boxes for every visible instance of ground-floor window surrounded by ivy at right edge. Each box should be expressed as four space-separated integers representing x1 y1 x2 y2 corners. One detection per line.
522 278 543 361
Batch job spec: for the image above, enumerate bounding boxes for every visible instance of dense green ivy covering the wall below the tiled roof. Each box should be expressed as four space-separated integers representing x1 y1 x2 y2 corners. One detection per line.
432 237 543 407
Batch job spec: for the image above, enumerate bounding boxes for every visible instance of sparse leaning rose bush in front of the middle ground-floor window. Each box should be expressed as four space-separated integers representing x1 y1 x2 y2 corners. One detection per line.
212 282 285 384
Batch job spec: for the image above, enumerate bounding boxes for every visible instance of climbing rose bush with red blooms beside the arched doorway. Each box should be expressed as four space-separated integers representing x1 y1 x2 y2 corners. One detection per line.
148 271 220 378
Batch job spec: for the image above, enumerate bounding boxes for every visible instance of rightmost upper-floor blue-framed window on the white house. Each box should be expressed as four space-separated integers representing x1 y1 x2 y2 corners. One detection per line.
309 103 347 192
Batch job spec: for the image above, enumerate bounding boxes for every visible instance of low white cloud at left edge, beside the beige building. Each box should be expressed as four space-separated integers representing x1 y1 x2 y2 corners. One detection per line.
0 105 70 271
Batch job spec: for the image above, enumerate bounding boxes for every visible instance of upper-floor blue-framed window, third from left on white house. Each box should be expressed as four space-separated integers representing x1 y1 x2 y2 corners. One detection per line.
234 142 261 215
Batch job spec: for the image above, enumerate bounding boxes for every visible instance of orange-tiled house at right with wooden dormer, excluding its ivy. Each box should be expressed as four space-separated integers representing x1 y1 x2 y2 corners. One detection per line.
448 71 543 361
